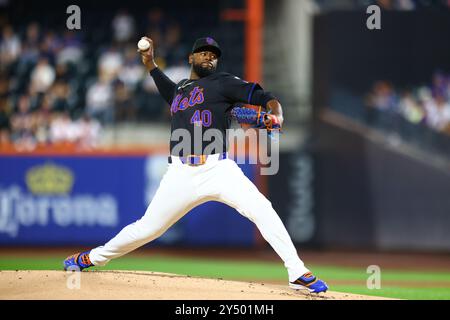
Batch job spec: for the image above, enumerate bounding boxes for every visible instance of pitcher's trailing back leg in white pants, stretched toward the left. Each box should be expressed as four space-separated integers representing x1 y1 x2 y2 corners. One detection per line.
89 166 196 266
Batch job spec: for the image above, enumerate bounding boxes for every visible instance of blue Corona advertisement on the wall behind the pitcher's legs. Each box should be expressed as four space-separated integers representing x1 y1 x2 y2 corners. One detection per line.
0 156 255 246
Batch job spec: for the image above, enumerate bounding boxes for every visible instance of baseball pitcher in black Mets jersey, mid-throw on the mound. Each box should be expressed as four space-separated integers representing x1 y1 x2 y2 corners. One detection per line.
64 37 328 293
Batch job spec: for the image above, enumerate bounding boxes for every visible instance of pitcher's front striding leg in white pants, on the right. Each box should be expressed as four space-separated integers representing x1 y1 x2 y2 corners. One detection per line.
219 160 309 281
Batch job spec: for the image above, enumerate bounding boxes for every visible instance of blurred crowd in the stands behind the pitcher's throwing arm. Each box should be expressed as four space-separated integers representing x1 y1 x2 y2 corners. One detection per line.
0 8 195 150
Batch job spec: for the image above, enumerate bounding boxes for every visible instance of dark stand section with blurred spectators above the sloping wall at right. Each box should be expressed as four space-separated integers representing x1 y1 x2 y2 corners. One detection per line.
314 0 450 158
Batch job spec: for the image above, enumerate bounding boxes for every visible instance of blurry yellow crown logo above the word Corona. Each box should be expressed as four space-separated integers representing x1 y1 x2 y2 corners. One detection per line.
26 163 74 194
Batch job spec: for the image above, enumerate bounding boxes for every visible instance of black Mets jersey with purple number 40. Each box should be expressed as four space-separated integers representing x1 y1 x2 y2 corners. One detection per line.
151 72 262 156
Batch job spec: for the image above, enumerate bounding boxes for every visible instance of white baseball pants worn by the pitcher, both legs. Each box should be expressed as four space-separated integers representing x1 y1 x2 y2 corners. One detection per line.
89 154 309 281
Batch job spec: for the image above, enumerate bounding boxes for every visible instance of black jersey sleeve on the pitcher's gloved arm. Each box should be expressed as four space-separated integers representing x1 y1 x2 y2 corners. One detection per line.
219 74 262 104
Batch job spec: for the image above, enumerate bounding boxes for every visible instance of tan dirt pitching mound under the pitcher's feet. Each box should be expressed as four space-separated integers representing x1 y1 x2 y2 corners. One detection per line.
0 271 386 300
